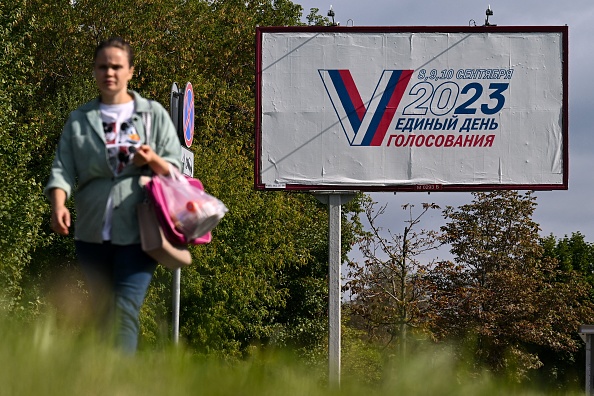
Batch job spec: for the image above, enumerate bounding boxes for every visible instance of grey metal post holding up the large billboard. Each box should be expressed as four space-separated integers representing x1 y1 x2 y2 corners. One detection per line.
315 192 355 386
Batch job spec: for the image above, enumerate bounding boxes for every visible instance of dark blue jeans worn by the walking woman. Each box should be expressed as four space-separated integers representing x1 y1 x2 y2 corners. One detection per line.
75 241 157 353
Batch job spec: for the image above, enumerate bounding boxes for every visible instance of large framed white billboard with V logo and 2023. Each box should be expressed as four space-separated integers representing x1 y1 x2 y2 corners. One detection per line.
254 26 568 191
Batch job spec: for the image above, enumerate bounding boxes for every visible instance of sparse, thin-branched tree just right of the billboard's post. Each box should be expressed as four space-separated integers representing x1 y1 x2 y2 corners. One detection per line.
344 198 439 355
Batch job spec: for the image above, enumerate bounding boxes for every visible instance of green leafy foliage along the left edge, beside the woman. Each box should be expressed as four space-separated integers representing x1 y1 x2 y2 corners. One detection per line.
0 1 47 314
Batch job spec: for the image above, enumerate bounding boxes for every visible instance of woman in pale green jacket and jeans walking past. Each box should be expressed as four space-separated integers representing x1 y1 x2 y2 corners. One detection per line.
44 38 181 353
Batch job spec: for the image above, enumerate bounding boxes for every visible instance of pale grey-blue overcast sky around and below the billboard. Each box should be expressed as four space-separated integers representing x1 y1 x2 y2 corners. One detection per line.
294 0 594 256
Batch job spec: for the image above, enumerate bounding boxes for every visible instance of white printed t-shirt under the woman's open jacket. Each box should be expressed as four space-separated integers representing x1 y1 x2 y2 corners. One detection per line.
99 101 137 241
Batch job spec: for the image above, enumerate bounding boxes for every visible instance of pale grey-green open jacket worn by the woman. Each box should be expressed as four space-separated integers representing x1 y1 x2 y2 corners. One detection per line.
44 91 181 245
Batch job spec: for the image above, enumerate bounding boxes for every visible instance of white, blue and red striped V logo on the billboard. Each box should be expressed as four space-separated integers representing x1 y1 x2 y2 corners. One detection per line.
318 69 413 146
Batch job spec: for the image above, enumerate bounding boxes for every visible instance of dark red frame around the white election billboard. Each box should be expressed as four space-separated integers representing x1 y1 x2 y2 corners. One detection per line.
254 26 569 192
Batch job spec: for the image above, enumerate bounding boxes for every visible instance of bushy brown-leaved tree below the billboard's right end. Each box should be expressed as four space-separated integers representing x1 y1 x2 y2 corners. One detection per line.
425 191 593 380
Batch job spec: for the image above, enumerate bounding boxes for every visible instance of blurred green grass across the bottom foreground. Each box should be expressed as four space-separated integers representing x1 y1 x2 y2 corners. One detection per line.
0 320 583 396
